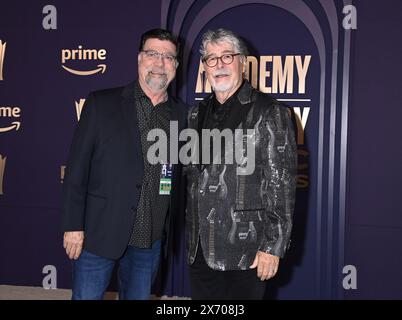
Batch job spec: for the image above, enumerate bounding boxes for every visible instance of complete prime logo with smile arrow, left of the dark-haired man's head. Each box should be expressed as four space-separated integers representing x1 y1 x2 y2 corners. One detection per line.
61 45 106 76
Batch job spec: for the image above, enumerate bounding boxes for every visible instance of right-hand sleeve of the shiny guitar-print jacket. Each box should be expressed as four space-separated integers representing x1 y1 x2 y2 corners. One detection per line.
259 105 297 257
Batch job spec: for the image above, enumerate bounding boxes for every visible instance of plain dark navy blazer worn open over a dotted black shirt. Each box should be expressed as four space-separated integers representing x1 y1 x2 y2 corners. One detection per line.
62 82 188 259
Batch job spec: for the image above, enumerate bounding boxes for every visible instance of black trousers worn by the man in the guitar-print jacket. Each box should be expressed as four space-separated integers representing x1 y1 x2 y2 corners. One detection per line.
189 245 266 300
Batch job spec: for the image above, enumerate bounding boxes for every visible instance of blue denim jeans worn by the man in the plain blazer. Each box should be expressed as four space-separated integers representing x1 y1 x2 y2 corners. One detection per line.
72 241 161 300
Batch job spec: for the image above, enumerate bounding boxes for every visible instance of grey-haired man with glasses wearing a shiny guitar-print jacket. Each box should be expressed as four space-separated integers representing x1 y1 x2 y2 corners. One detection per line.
186 29 297 299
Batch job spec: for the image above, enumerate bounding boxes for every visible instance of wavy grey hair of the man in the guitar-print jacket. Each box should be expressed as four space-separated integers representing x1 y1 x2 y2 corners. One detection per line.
200 28 248 58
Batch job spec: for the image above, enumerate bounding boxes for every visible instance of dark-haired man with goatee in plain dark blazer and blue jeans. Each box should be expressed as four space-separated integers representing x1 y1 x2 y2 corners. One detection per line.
62 29 188 299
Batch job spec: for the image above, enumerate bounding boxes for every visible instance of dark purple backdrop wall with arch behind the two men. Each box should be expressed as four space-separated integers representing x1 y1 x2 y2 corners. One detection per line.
0 0 402 299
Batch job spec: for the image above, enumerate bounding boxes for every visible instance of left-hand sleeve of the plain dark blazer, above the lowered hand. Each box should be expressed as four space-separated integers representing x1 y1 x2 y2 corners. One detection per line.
61 93 96 231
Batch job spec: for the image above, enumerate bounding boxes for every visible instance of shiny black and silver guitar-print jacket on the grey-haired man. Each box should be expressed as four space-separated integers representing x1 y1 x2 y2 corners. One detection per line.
185 81 297 271
